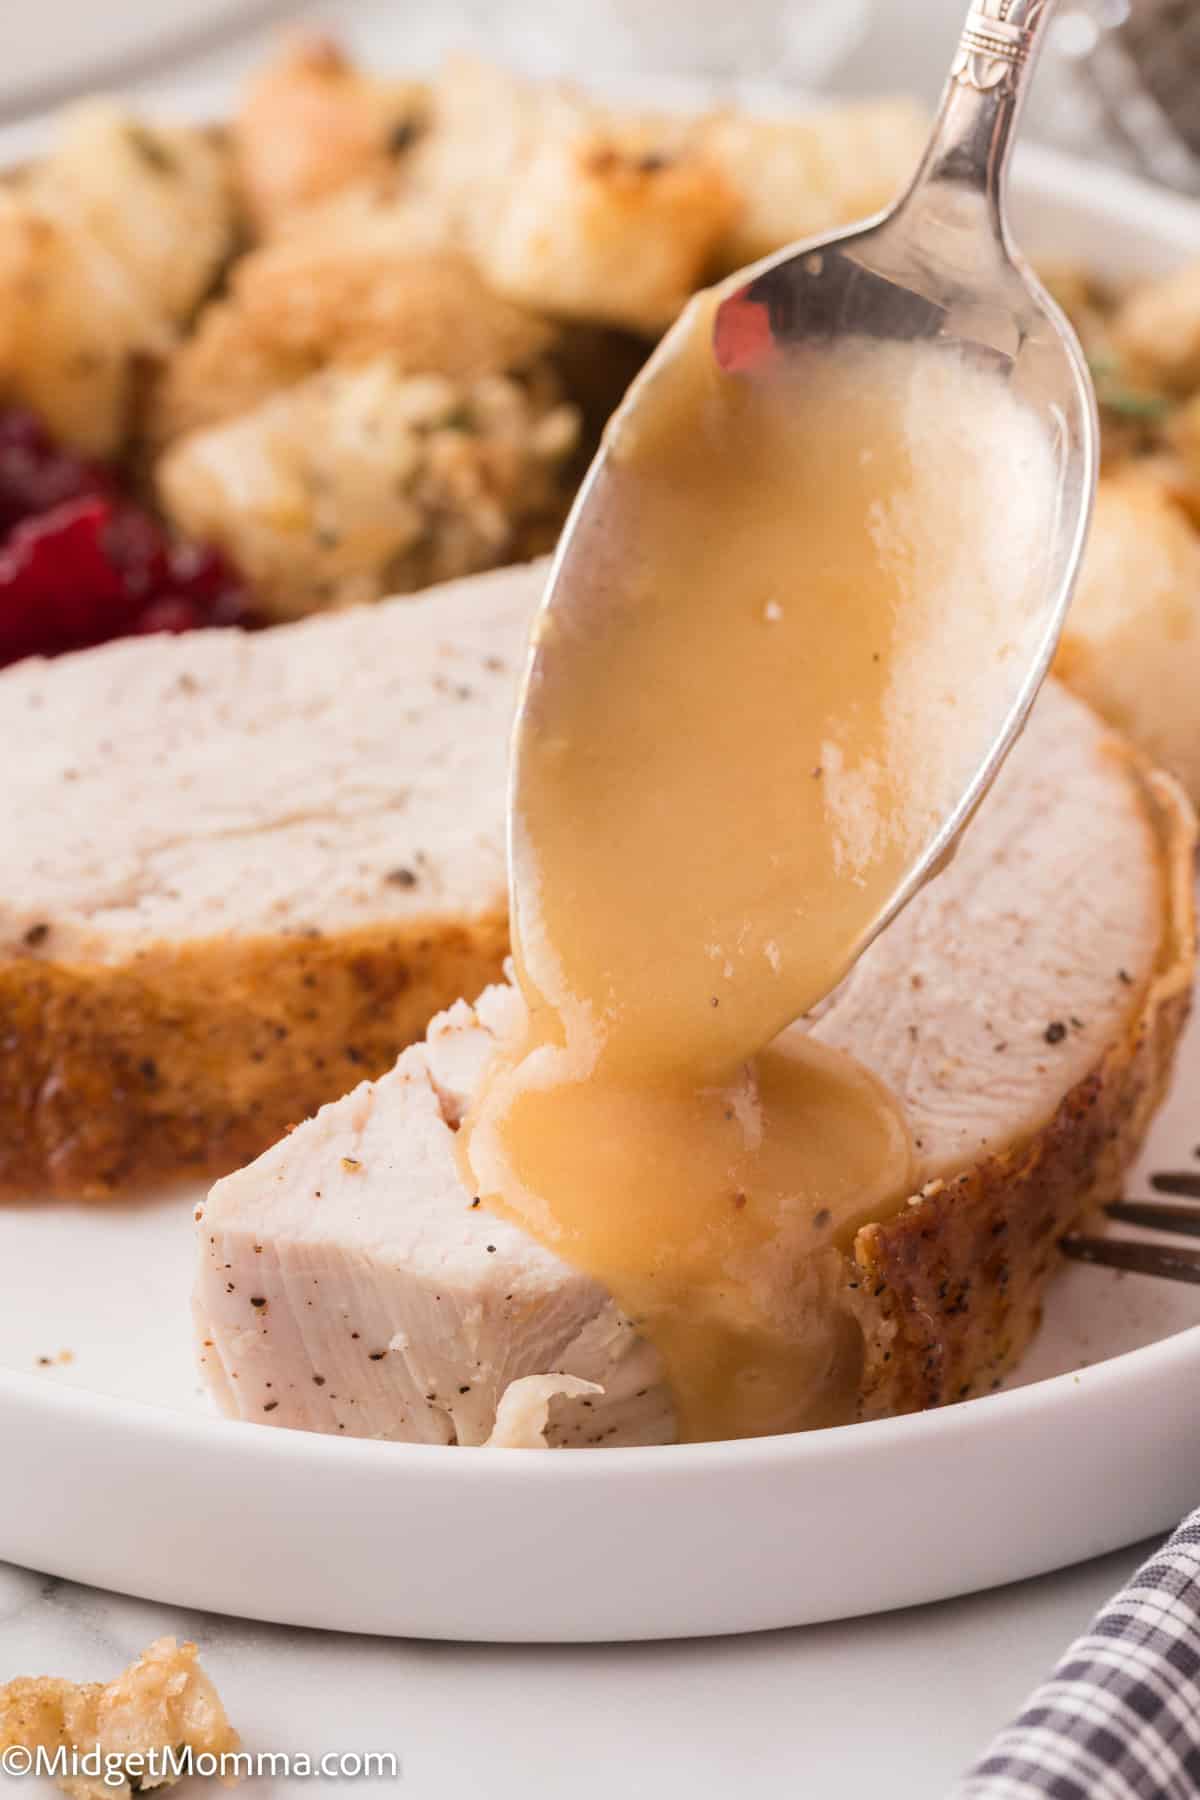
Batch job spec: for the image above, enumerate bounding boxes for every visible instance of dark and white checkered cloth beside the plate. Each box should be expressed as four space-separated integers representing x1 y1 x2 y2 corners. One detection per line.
954 1512 1200 1800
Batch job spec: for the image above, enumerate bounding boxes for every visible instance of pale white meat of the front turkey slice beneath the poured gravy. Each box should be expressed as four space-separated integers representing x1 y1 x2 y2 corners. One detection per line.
196 684 1191 1445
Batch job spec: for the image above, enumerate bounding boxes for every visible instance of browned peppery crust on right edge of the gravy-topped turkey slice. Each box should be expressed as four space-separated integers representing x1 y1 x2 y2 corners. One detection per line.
849 751 1196 1418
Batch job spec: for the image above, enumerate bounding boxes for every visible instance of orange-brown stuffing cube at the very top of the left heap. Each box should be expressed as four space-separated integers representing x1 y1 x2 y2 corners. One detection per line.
232 38 426 232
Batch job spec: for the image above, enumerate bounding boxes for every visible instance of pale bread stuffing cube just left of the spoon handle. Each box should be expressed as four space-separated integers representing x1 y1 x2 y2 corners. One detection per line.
698 99 928 270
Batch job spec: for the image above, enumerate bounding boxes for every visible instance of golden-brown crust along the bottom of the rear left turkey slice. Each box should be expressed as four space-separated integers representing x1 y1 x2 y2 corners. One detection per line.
0 907 507 1199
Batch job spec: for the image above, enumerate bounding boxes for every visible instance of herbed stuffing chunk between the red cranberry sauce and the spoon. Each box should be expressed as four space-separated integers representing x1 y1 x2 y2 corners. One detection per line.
157 356 578 619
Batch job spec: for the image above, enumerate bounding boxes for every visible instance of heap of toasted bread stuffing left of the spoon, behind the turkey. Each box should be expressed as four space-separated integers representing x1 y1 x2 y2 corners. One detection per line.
0 38 1043 640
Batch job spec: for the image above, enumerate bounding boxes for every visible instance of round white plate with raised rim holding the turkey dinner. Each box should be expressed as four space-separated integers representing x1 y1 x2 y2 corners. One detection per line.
0 153 1200 1642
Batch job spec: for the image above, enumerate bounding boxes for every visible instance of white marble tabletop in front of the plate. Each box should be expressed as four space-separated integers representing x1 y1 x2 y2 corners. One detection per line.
0 1540 1150 1800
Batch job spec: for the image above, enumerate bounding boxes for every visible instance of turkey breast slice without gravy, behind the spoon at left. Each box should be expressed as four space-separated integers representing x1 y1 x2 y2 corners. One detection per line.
0 563 528 1195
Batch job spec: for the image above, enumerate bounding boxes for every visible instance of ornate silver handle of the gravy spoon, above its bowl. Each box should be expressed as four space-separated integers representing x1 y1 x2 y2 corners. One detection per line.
905 0 1056 229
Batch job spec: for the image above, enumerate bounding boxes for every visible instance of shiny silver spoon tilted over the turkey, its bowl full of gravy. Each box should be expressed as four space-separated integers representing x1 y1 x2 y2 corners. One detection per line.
509 0 1097 1028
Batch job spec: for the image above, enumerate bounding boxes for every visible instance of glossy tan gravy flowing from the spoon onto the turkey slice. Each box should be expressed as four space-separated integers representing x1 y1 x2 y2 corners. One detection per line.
461 295 1054 1438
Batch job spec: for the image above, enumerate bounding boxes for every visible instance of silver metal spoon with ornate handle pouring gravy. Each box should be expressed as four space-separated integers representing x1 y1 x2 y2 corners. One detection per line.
509 0 1099 1015
